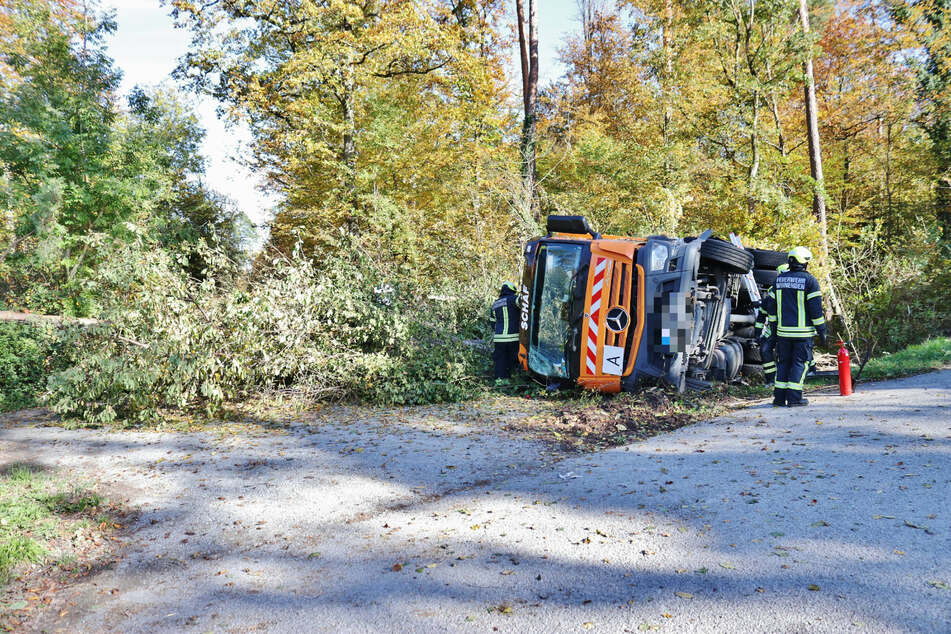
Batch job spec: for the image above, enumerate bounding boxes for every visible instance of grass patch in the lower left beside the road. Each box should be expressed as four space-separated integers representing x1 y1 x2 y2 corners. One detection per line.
0 466 103 589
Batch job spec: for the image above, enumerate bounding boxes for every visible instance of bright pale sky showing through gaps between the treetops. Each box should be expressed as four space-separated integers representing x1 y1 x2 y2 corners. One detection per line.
103 0 578 225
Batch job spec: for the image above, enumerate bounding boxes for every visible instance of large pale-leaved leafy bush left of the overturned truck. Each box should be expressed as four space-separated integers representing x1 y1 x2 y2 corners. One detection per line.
47 239 484 423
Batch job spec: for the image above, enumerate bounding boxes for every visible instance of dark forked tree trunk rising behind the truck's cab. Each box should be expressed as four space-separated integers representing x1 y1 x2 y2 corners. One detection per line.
515 0 540 221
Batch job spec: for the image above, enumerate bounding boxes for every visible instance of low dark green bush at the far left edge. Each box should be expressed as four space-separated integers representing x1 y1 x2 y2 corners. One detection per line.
0 323 52 412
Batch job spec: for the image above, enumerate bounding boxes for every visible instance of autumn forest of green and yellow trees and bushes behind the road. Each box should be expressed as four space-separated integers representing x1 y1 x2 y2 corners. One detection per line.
0 0 951 424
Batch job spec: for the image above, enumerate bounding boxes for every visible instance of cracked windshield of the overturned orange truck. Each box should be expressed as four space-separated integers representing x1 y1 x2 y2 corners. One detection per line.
528 243 582 378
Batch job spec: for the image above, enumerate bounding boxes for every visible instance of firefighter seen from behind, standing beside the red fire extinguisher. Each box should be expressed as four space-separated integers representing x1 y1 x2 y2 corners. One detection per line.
763 247 826 407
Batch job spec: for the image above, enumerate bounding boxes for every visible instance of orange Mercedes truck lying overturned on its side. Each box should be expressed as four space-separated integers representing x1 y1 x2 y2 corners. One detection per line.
519 216 785 392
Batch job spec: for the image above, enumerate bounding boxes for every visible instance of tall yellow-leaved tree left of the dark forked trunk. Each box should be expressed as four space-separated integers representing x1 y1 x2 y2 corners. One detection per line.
169 0 506 271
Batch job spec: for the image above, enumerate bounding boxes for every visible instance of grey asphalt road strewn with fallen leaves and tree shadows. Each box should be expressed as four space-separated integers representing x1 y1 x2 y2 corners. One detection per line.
0 371 951 632
